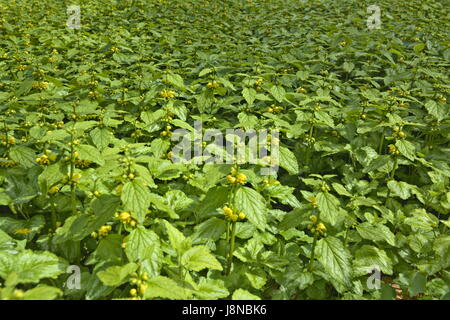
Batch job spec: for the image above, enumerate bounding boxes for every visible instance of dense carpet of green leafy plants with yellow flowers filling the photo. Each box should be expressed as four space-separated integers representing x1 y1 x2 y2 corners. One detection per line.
0 0 450 299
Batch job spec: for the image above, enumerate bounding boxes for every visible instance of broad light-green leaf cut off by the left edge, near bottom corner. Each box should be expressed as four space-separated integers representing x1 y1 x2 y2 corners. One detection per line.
0 250 66 283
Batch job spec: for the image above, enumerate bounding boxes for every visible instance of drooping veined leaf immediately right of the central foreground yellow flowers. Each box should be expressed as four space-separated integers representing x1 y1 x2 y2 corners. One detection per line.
234 187 267 231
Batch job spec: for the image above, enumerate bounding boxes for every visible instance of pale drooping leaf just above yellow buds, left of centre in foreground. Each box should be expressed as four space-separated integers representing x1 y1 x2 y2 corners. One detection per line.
120 178 151 223
